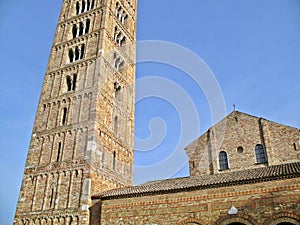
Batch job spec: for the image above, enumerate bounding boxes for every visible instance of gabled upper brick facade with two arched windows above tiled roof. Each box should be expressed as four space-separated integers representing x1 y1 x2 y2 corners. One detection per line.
186 111 300 176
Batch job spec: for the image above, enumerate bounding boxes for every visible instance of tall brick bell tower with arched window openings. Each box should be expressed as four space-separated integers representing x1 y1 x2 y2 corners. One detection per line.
14 0 137 224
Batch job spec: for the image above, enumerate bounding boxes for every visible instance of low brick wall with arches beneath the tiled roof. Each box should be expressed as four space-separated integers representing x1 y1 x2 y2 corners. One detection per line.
98 178 300 225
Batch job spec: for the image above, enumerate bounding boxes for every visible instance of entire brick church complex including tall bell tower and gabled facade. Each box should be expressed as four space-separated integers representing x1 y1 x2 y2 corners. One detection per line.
14 0 300 225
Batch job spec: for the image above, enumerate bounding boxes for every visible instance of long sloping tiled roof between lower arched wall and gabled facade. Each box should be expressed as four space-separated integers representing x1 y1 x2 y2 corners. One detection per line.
92 162 300 200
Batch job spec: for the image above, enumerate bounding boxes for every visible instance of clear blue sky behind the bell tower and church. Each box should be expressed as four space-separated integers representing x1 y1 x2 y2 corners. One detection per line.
0 0 300 225
